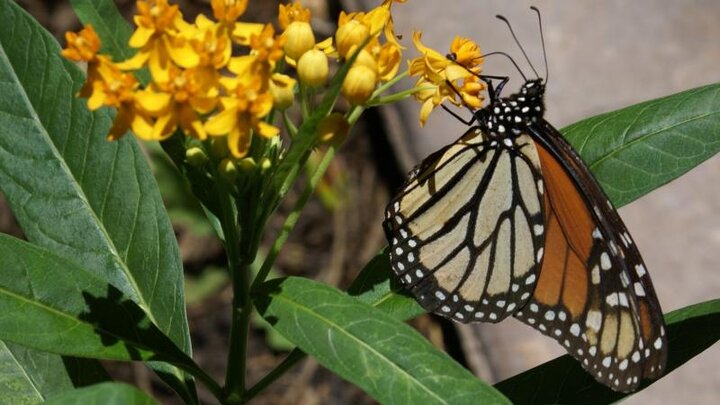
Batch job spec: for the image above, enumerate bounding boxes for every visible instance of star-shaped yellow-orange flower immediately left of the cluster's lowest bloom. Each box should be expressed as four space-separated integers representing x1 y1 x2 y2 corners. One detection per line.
136 67 217 140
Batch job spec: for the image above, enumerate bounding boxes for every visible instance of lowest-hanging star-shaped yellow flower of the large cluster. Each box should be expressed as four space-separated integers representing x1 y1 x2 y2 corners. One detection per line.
205 83 280 158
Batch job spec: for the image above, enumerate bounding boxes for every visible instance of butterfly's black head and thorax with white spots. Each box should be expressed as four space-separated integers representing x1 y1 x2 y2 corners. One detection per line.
480 79 545 136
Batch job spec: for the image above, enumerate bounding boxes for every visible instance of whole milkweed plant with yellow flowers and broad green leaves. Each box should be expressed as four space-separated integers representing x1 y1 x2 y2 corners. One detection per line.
0 0 720 404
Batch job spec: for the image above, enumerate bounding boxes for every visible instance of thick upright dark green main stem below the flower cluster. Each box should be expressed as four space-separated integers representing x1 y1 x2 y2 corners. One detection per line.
219 186 252 403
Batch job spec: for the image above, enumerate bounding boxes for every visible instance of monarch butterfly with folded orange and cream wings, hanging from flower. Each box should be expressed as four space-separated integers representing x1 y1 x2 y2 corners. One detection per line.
383 8 667 392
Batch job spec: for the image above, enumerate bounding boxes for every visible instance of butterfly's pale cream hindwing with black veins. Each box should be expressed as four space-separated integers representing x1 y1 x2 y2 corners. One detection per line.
383 128 544 322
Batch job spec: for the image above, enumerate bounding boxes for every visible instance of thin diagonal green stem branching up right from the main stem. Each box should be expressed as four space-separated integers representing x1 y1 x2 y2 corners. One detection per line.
251 146 335 290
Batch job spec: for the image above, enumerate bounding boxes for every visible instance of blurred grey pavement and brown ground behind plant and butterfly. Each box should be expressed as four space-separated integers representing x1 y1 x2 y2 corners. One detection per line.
7 0 720 405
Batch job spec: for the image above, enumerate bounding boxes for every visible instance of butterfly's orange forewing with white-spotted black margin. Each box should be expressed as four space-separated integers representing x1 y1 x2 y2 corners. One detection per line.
516 121 667 391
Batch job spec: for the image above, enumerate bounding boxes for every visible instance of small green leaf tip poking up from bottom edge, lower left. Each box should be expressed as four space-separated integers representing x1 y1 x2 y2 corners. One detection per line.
45 382 160 405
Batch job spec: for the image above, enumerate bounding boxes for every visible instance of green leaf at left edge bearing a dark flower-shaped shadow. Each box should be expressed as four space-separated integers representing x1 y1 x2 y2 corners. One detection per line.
0 234 194 368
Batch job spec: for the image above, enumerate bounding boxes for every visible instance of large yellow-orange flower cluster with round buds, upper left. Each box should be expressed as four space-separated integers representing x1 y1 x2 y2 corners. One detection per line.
63 0 404 158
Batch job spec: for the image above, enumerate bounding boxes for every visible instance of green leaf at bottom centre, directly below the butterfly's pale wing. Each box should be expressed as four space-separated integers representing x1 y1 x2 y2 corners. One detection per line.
257 277 508 404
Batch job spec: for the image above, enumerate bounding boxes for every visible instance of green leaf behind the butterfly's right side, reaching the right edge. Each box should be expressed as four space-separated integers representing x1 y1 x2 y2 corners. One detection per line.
562 84 720 207
